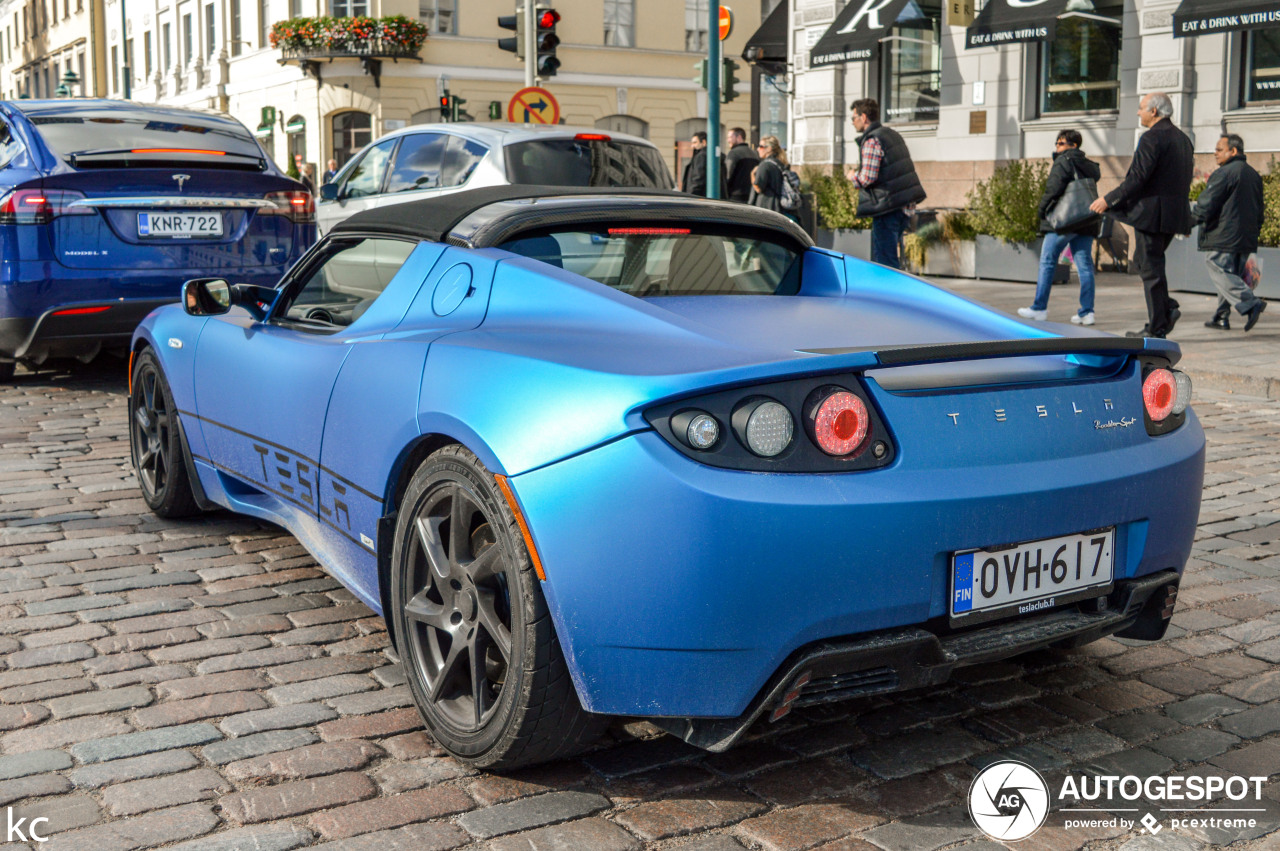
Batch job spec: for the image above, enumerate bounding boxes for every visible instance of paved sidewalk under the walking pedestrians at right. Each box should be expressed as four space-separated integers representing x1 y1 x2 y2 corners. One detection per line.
929 273 1280 399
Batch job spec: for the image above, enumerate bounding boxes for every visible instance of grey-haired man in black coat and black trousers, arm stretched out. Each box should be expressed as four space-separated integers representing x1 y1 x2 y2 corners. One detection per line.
1089 92 1196 337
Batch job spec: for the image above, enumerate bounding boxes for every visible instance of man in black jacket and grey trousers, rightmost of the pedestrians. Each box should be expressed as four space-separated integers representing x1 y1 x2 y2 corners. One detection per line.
1192 133 1267 330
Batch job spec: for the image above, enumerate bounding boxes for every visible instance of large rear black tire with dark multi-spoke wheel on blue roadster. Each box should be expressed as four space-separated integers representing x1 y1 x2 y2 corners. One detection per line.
390 445 608 769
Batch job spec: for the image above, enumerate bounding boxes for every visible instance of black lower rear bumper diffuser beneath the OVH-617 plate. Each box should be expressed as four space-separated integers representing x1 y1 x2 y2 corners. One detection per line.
653 571 1180 751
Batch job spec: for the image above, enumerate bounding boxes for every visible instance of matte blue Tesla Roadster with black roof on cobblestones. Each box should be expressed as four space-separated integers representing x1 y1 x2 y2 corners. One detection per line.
129 187 1204 768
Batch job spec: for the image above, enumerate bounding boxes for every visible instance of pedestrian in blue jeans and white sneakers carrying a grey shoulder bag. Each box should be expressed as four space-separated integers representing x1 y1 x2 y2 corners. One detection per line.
1018 131 1102 325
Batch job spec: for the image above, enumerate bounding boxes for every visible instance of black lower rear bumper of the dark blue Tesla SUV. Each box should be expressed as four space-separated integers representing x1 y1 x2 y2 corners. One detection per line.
0 298 174 363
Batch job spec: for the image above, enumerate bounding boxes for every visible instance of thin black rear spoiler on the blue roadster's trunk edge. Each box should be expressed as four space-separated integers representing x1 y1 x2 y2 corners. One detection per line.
796 335 1181 369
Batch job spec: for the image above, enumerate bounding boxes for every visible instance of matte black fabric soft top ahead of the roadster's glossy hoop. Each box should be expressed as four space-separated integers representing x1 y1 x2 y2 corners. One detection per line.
330 184 691 242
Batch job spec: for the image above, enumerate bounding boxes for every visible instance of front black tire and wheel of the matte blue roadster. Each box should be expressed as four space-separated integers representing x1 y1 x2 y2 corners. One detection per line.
129 349 200 518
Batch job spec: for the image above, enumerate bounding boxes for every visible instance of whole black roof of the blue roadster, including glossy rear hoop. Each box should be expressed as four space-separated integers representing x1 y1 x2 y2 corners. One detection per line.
330 184 813 248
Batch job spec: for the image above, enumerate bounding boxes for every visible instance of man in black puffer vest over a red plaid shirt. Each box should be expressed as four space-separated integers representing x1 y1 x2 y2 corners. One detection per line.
849 97 924 269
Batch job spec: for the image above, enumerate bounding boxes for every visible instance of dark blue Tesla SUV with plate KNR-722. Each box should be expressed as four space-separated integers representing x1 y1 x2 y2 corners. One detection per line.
0 100 315 380
